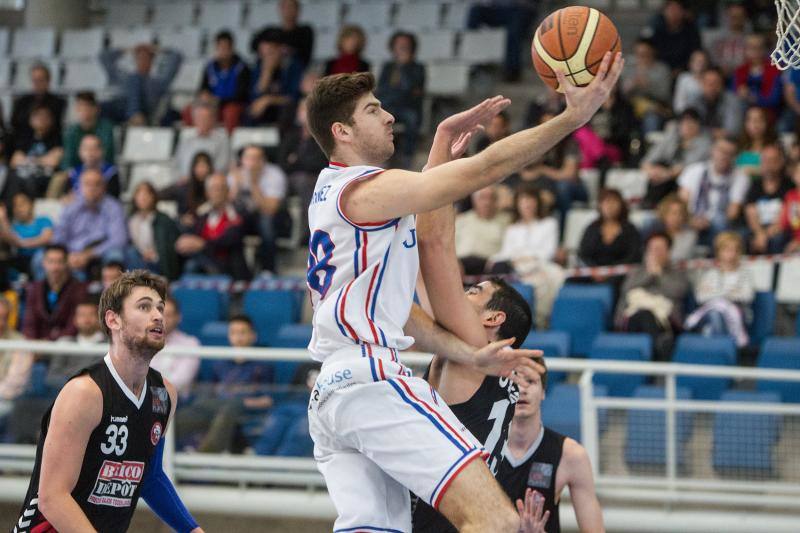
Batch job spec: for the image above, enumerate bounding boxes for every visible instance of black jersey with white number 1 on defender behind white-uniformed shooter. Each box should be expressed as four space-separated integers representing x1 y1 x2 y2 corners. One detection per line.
413 367 519 533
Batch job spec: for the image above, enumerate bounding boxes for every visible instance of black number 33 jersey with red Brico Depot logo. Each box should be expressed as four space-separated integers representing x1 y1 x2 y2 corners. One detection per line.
13 355 170 533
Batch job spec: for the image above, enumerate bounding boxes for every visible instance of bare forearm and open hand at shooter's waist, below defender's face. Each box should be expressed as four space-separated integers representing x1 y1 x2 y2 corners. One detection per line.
404 305 544 377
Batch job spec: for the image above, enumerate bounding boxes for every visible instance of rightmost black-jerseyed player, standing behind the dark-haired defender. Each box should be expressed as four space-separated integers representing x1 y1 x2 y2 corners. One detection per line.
497 362 604 533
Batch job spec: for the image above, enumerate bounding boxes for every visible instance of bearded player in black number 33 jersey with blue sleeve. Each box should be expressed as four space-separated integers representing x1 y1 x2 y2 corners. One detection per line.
13 271 202 533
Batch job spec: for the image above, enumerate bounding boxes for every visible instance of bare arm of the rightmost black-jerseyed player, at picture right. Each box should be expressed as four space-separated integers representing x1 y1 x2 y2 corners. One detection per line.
561 438 605 533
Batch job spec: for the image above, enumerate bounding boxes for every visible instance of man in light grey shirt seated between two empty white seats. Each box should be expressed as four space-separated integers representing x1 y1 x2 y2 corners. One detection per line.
175 100 231 176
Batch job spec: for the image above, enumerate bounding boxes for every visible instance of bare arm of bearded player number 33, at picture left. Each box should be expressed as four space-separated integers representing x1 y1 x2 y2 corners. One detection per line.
39 376 103 533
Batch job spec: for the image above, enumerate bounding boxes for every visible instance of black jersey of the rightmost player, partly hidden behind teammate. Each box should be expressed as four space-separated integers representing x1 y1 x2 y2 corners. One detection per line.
497 428 566 533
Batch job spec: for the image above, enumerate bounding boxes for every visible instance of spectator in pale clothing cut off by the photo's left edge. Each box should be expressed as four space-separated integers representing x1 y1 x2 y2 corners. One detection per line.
0 296 33 435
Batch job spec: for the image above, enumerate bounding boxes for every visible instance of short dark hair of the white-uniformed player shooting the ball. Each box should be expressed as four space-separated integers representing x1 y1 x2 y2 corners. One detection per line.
306 72 375 157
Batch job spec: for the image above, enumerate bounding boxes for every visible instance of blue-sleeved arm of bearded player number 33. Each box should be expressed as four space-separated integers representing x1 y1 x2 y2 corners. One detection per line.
141 379 203 533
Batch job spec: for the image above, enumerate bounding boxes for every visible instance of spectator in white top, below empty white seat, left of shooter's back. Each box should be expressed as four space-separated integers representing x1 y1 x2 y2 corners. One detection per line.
228 145 286 272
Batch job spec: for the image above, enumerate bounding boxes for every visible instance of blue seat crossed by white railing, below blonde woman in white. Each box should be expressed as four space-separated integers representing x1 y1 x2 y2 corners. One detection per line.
672 333 736 400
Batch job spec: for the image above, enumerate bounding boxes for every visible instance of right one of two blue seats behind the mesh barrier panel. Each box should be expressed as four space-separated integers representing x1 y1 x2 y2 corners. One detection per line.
712 391 781 475
